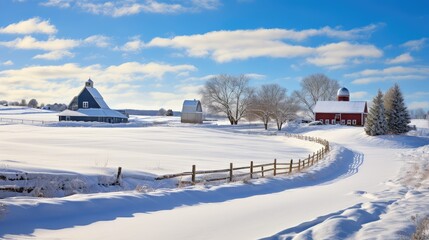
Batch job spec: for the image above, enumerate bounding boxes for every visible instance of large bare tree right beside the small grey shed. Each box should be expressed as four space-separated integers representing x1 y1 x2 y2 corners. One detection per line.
200 75 253 125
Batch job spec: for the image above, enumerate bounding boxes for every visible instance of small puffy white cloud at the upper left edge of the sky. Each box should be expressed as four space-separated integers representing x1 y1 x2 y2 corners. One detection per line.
0 17 57 35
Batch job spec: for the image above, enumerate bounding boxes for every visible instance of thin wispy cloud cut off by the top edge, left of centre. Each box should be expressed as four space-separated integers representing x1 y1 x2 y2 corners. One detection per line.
41 0 220 17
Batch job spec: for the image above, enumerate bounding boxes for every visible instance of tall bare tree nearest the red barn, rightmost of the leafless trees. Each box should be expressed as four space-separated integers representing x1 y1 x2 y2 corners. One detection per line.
293 73 340 118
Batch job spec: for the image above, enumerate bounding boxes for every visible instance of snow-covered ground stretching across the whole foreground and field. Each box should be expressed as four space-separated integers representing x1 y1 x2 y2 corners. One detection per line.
0 109 429 239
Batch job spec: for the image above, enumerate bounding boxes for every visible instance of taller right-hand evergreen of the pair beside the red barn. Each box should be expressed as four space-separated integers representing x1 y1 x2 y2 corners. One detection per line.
384 84 410 134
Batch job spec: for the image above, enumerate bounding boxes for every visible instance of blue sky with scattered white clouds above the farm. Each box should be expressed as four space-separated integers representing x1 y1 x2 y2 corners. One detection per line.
0 0 429 111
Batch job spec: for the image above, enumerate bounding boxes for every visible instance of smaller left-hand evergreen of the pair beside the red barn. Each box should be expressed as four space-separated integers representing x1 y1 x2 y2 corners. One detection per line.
365 90 387 136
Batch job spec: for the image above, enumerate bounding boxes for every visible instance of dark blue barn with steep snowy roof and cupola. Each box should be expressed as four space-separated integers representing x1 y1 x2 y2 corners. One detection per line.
58 79 128 123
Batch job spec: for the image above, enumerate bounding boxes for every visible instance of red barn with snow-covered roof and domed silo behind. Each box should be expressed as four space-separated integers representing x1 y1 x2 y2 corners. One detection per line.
313 87 368 126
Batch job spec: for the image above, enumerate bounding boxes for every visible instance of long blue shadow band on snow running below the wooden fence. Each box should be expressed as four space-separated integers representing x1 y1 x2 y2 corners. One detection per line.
0 146 363 238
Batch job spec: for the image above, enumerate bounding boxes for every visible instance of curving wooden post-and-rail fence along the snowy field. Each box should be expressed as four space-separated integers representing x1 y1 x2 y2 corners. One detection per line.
155 134 330 184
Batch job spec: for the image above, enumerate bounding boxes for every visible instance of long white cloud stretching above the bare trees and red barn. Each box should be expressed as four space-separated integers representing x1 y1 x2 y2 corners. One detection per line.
146 25 382 66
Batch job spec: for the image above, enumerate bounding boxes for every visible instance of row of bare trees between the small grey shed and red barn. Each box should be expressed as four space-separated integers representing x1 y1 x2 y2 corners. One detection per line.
200 74 340 130
